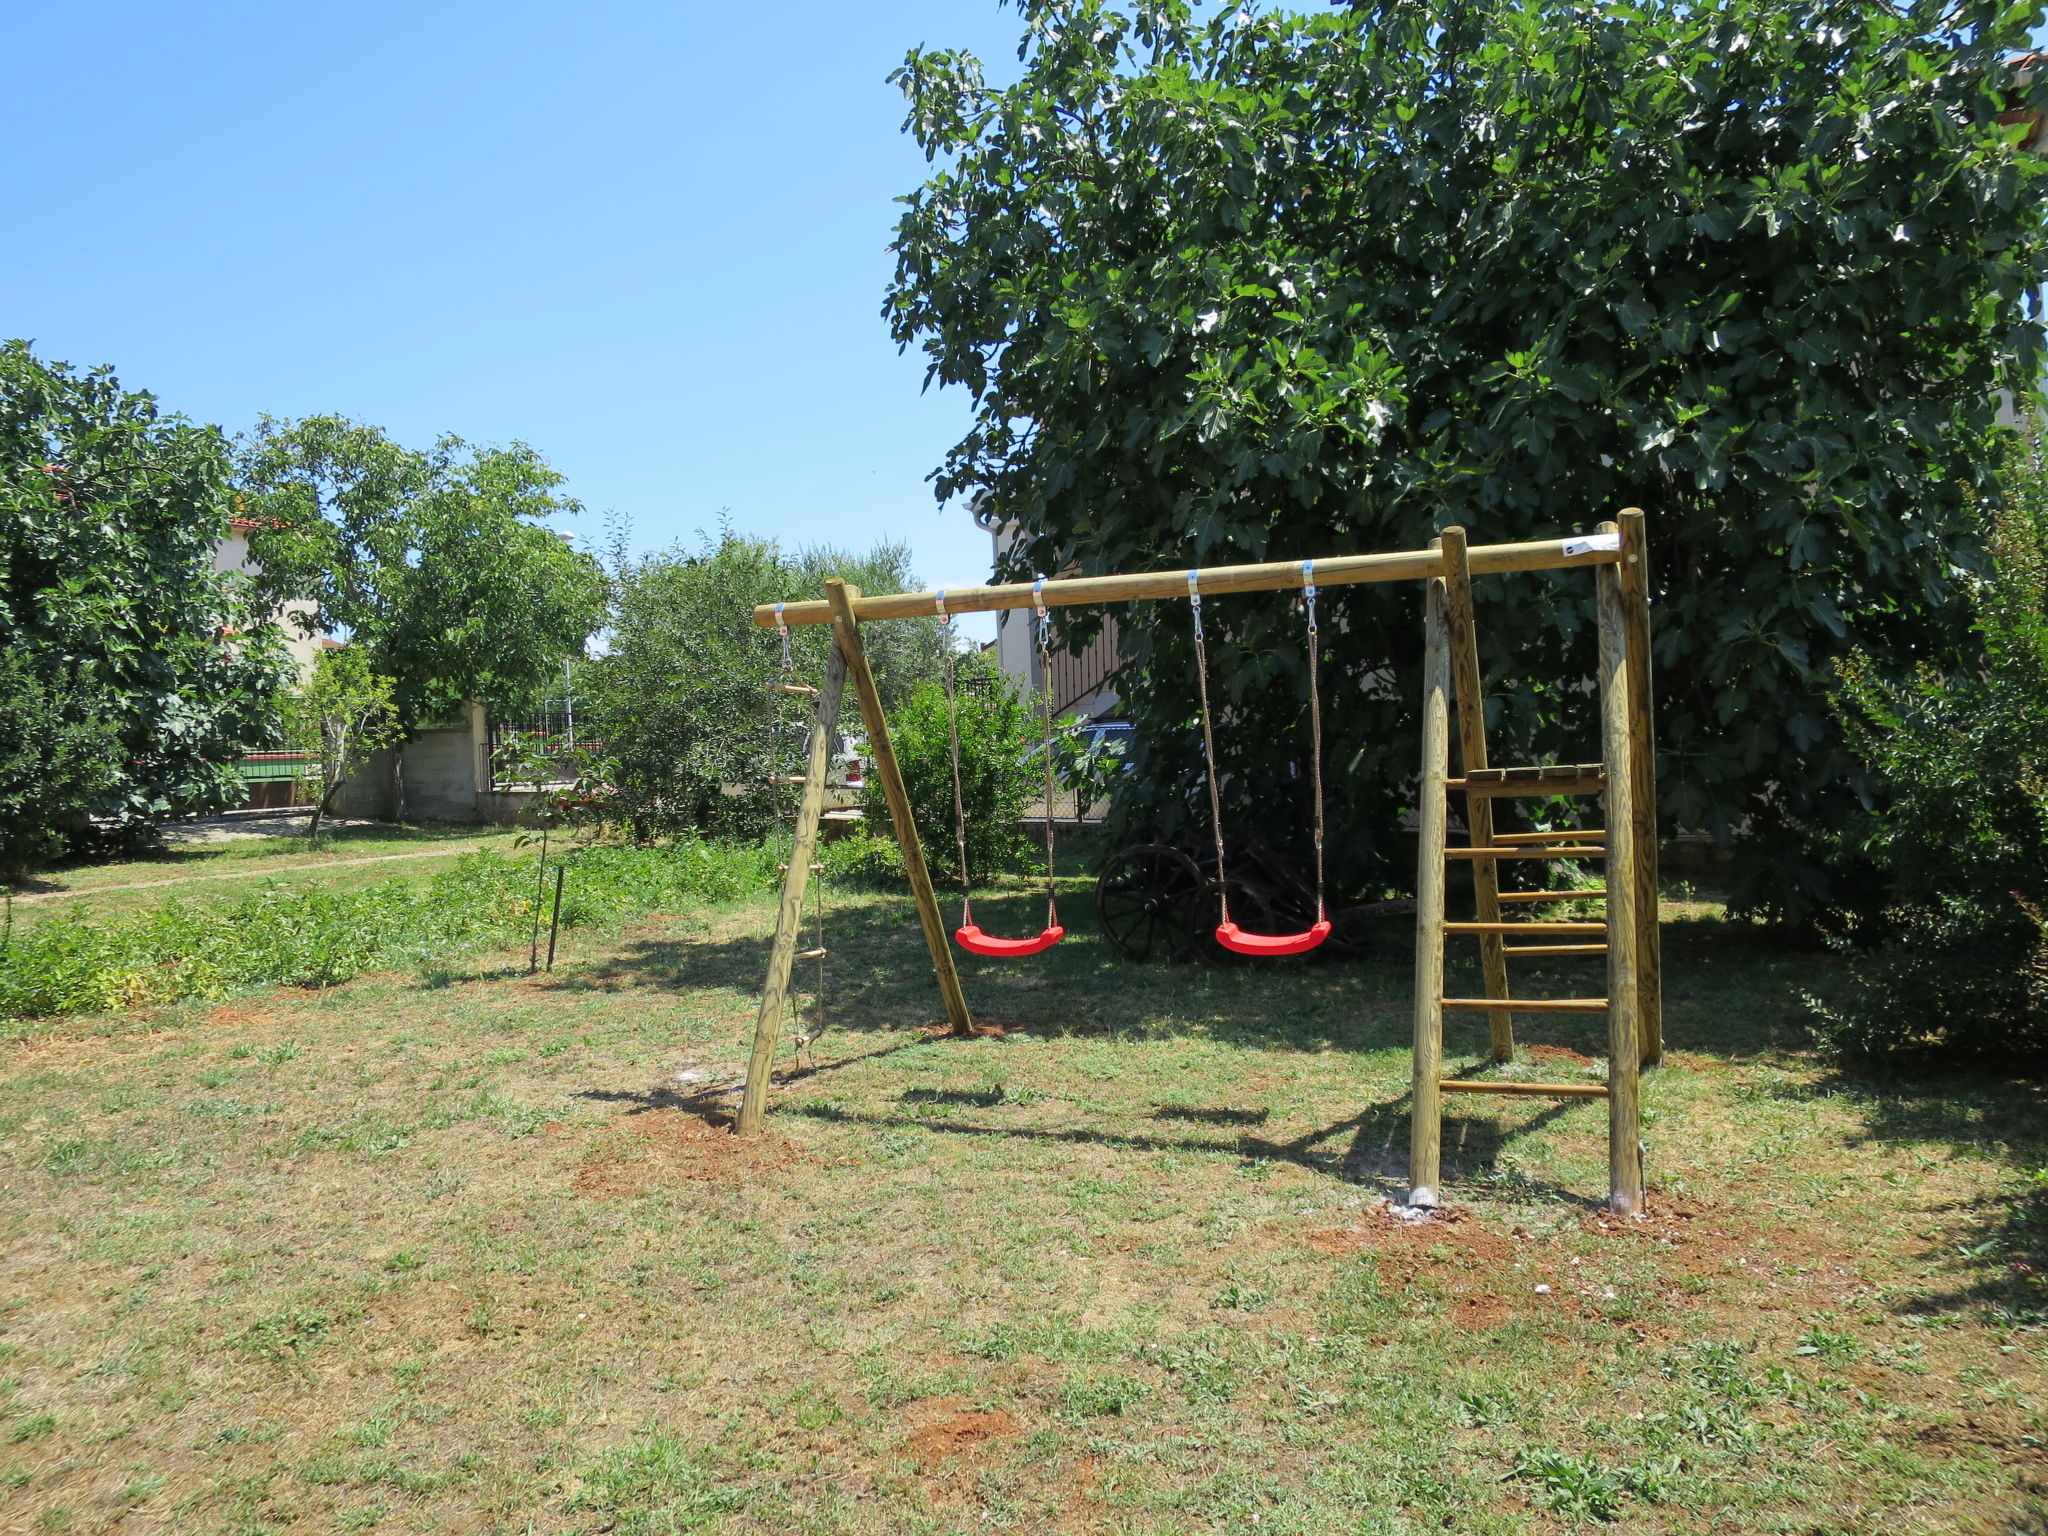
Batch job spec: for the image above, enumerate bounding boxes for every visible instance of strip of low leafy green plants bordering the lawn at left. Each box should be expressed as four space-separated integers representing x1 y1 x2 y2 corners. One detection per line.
0 838 774 1020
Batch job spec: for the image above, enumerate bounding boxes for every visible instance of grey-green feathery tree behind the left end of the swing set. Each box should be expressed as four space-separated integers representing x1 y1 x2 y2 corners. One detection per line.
584 528 944 838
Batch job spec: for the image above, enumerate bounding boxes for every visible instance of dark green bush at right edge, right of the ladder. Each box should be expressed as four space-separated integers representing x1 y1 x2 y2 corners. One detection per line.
1812 442 2048 1065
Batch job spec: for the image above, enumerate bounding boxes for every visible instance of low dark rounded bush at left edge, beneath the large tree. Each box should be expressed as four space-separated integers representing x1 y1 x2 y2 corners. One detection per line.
0 651 121 879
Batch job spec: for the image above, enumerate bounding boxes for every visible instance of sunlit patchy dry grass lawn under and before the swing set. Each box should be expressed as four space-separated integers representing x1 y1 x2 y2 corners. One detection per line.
0 866 2048 1536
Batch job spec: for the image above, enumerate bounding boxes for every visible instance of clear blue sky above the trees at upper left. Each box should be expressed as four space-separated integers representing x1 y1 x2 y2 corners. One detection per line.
0 0 1022 638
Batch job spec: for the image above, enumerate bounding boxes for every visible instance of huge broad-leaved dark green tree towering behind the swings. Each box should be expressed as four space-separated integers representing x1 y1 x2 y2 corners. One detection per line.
887 0 2048 913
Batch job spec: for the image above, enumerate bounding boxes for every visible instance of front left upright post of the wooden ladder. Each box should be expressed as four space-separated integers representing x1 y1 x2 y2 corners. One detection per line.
1407 578 1450 1206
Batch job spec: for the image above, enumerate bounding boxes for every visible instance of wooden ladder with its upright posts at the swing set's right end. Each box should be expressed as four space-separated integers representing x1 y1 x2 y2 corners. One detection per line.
1409 512 1661 1212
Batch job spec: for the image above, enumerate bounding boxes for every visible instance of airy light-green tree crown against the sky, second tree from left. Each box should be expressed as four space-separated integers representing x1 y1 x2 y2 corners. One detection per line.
242 416 606 731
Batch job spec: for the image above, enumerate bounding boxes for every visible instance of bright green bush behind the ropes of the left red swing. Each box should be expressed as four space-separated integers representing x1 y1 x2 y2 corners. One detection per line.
860 664 1044 881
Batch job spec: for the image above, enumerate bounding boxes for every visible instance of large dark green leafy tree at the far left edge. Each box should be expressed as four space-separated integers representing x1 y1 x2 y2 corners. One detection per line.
0 342 289 858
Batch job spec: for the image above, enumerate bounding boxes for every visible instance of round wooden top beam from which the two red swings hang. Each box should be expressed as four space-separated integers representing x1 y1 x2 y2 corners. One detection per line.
754 535 1622 629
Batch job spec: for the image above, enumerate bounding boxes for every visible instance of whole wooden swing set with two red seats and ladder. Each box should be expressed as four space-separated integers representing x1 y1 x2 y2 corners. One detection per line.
735 508 1663 1214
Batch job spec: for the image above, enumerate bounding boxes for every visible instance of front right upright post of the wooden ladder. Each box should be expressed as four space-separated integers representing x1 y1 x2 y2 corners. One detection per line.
1593 540 1642 1217
